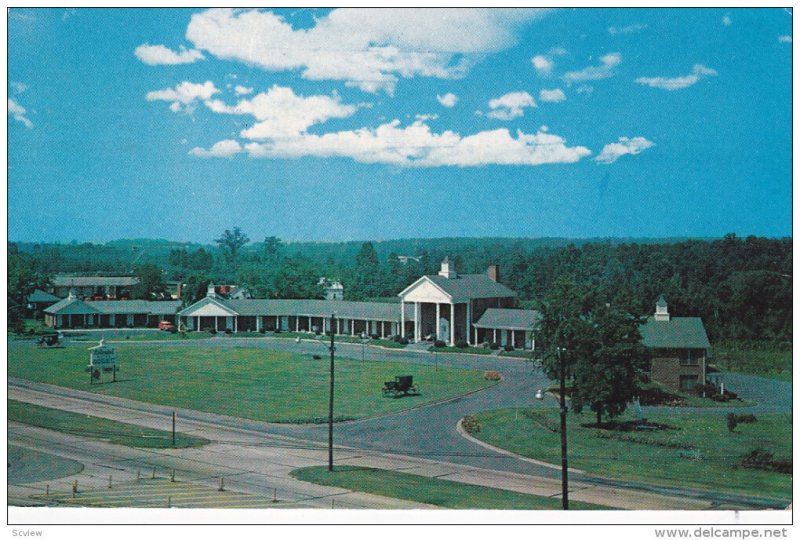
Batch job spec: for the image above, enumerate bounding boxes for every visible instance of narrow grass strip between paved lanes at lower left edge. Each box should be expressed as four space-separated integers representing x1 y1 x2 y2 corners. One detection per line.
8 399 209 448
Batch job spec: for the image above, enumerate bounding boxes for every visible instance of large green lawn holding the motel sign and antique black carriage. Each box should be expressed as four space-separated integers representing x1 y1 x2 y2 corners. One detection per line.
8 342 495 422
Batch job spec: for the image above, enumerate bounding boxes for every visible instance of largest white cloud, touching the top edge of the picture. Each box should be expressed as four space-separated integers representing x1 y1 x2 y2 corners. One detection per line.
186 9 546 94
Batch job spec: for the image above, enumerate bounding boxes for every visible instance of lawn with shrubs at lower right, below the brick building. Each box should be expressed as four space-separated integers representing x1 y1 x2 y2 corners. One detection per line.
474 409 792 501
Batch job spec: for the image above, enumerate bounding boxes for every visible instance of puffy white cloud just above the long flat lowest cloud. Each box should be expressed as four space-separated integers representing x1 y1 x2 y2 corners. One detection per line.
205 85 358 139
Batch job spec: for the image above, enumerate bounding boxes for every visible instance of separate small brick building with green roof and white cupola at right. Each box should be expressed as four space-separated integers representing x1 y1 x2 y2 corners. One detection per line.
639 296 711 390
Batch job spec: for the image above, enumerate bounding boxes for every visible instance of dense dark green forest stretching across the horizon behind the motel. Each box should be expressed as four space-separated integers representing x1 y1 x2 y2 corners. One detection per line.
8 234 792 348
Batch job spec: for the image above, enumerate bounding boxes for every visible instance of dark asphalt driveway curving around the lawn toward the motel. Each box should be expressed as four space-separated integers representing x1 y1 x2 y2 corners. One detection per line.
7 337 791 507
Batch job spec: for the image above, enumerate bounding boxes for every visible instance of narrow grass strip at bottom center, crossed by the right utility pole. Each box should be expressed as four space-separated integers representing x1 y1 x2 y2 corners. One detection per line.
291 466 610 510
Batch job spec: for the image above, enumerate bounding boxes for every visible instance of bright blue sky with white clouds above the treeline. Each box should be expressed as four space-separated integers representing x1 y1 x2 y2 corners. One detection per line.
8 9 793 242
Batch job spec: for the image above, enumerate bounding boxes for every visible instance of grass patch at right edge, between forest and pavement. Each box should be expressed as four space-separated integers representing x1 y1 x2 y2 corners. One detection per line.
710 342 792 382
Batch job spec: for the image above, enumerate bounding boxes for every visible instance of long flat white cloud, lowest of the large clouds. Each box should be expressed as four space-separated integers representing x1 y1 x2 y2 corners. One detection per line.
244 120 591 167
